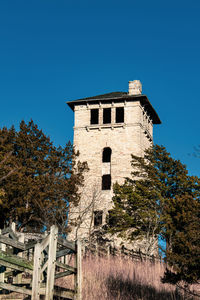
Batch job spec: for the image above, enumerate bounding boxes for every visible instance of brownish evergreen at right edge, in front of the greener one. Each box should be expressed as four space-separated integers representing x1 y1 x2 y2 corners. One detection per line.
163 194 200 284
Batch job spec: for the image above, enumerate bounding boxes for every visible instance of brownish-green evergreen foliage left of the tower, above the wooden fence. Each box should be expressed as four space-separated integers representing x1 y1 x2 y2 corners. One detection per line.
0 120 87 232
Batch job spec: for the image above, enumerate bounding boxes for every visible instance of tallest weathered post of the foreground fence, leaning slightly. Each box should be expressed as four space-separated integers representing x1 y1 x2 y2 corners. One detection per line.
45 225 58 300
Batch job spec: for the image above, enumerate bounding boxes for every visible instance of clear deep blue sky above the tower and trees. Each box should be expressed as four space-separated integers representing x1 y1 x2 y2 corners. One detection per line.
0 0 200 176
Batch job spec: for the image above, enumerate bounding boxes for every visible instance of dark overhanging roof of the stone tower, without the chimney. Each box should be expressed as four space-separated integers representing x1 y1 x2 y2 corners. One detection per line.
67 92 161 124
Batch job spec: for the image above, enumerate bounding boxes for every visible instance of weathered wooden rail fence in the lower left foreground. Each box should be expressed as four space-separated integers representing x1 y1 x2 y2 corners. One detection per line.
0 224 81 300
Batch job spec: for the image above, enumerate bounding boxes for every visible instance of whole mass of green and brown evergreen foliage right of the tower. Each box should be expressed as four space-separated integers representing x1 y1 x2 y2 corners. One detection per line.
109 145 200 283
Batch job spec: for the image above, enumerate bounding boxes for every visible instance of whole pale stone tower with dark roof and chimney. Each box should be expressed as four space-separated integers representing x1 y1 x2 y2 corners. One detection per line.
67 80 161 246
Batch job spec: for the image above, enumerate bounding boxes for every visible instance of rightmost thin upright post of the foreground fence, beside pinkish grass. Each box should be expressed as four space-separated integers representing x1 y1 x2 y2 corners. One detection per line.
74 240 82 300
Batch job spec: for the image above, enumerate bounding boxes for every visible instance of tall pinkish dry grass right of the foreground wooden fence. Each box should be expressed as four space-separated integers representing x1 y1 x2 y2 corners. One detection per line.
59 257 197 300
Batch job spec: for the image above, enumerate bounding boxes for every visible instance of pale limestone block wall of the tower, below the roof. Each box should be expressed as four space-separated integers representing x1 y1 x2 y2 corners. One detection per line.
69 101 153 238
